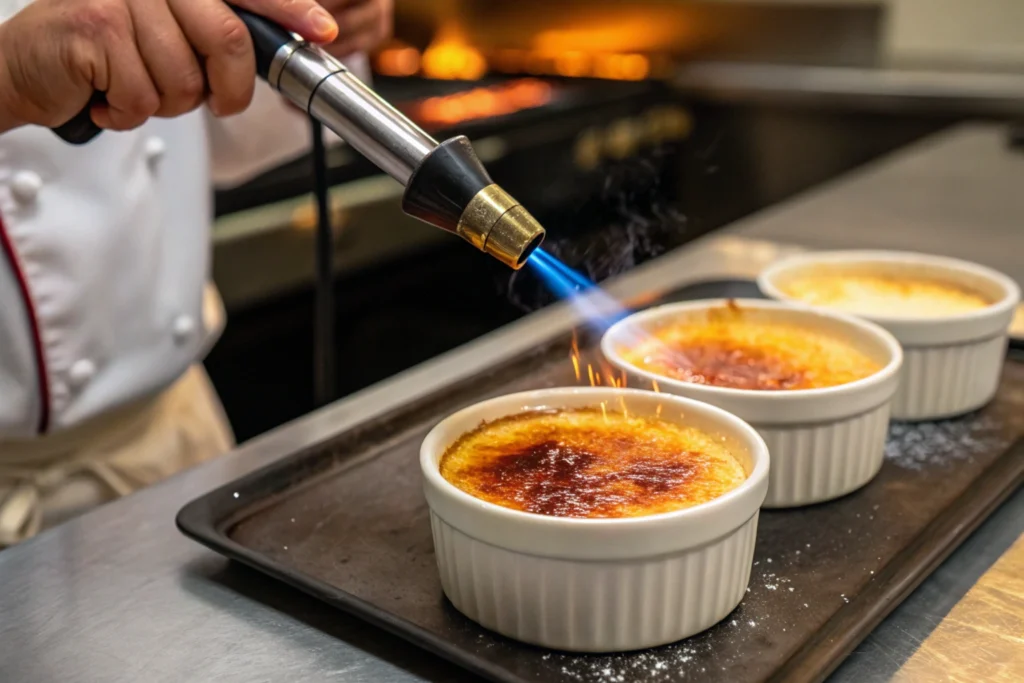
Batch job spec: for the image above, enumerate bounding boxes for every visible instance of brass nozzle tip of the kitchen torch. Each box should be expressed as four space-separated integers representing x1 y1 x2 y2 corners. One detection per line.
456 184 544 269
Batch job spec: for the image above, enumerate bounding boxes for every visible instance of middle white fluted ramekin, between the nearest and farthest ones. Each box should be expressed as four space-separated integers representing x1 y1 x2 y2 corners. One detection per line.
601 299 902 508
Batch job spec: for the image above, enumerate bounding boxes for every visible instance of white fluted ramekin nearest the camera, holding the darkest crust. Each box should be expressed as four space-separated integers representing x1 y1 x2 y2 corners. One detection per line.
420 388 768 652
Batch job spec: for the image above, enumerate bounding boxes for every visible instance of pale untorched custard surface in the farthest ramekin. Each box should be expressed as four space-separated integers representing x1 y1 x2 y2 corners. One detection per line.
779 270 992 317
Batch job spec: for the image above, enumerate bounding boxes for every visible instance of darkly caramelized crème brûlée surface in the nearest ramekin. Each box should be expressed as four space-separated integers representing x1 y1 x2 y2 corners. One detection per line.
440 407 746 518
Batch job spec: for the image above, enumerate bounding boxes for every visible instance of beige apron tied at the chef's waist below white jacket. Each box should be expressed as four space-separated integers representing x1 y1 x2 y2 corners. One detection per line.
0 364 234 549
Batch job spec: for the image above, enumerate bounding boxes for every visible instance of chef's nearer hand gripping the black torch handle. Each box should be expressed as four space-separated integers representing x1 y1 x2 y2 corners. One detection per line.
0 0 338 132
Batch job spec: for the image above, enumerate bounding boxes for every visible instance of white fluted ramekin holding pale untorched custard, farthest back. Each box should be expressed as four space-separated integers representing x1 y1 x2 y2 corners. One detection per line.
758 251 1020 420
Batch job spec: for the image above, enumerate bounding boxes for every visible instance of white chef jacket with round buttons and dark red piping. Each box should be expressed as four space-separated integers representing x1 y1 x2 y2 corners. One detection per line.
0 0 366 442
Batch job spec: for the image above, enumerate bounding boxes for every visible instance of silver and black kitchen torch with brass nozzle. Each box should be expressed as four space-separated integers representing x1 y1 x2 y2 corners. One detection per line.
54 7 544 269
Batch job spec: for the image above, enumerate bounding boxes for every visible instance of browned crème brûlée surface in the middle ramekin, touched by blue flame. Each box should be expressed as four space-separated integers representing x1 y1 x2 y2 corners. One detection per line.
620 302 881 391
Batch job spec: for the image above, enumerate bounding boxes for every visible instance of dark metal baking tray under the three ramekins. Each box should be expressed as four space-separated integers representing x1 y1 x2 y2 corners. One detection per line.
178 282 1024 683
